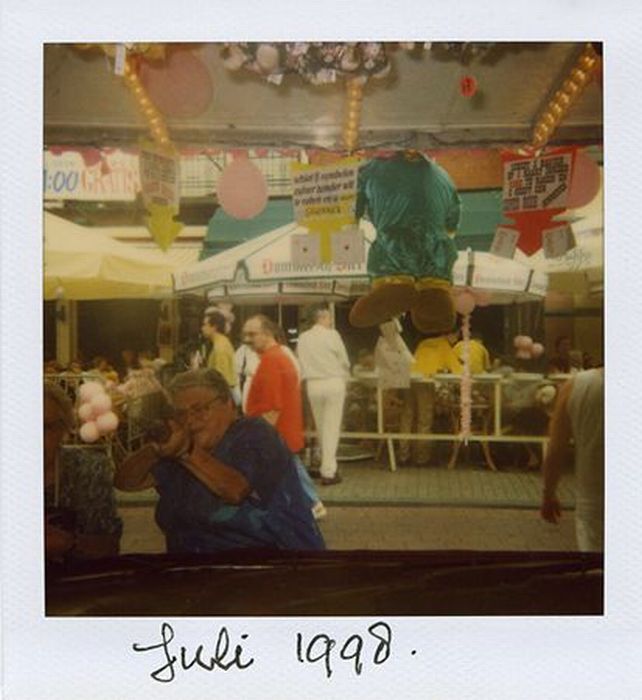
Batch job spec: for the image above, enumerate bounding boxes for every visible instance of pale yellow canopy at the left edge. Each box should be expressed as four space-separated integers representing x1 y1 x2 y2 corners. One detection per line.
44 212 174 300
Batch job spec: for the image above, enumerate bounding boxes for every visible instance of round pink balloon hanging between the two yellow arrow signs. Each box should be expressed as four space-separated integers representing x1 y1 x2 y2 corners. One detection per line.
217 158 268 219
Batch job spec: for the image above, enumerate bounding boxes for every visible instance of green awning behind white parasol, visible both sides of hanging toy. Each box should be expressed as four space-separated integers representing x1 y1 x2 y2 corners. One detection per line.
200 189 508 260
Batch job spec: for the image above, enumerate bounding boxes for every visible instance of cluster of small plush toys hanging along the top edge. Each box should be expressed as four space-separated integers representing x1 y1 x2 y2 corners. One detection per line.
221 41 400 85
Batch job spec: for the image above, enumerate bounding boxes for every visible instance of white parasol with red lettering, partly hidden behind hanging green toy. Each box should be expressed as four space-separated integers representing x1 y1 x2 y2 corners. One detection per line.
174 221 547 304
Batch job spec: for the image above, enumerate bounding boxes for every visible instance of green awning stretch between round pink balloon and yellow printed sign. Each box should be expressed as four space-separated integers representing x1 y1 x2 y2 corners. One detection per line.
199 198 294 260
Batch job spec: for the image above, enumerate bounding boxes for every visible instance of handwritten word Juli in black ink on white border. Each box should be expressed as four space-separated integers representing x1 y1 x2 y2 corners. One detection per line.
132 622 254 683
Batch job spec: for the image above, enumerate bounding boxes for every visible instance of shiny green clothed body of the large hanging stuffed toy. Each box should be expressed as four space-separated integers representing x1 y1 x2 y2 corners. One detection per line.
356 154 461 282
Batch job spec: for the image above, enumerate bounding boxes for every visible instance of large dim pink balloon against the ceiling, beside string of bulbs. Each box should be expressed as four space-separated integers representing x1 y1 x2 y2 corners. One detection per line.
140 49 214 118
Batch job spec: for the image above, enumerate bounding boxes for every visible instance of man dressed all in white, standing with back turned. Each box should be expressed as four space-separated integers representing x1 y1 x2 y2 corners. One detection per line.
297 306 350 486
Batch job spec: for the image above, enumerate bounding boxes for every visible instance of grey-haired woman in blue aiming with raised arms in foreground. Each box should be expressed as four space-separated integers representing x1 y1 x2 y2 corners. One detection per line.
114 369 325 553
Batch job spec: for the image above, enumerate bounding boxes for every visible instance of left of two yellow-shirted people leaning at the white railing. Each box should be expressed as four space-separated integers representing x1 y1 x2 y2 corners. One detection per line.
399 335 462 465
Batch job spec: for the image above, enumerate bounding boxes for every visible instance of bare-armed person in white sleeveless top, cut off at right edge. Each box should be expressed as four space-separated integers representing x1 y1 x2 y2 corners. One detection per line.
541 368 604 552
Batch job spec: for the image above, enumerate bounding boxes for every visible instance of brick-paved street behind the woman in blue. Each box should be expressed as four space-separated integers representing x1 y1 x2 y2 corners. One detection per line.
118 460 575 553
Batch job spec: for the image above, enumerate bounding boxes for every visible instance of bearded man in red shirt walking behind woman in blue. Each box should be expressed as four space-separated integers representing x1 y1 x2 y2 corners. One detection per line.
243 314 326 518
